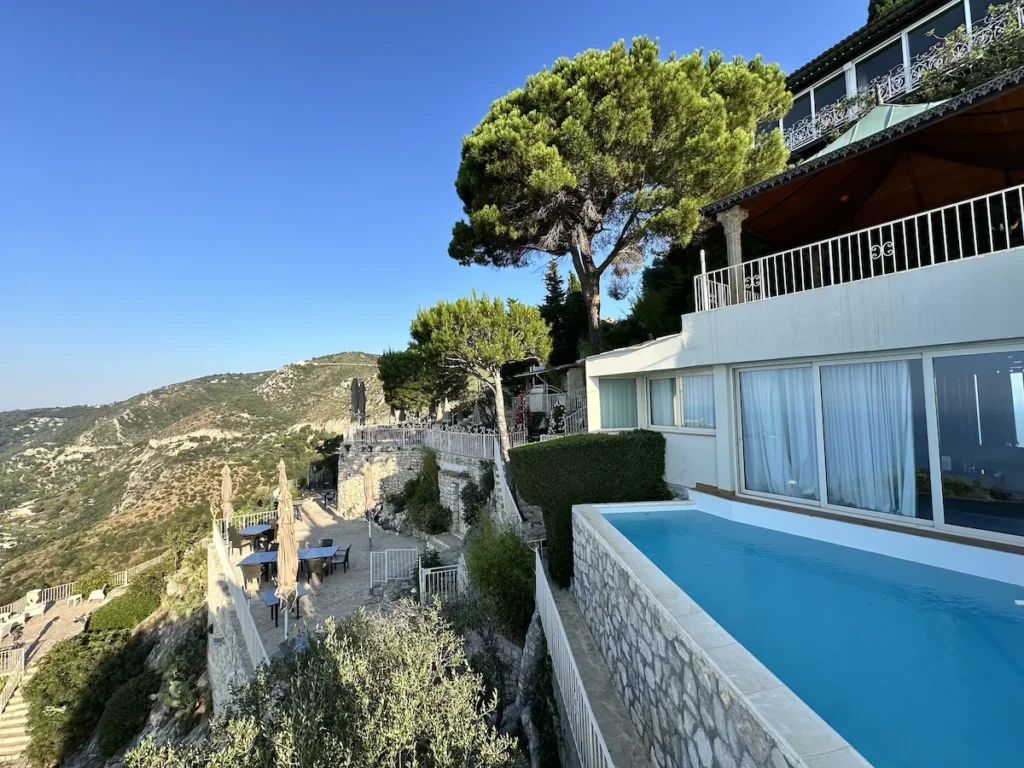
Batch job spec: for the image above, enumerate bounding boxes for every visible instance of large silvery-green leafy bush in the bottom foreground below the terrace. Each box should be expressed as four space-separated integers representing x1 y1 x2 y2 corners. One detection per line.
125 601 516 768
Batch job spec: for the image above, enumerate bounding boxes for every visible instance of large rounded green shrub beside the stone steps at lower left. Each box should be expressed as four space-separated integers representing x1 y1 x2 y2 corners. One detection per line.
25 631 151 766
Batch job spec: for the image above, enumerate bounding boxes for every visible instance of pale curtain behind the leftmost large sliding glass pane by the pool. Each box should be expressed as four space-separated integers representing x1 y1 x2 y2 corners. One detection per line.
739 368 818 499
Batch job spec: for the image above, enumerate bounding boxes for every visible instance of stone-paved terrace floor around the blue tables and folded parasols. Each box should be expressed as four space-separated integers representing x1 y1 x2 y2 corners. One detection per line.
231 499 424 654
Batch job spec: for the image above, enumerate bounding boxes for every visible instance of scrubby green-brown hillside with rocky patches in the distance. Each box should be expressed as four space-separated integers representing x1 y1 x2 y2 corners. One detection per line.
0 352 389 604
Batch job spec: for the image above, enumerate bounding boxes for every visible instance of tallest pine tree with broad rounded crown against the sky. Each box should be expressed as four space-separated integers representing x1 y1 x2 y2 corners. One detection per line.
449 37 793 351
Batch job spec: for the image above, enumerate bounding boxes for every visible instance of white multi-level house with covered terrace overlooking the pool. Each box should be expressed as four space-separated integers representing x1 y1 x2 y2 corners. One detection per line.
586 66 1024 545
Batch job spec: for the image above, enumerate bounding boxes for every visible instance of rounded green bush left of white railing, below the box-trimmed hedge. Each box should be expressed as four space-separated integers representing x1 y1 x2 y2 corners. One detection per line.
466 518 535 642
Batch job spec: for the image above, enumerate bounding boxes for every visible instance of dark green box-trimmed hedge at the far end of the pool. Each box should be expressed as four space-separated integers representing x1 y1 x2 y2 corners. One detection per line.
511 429 672 587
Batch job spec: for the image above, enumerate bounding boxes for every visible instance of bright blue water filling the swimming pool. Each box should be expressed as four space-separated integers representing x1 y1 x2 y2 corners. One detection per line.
606 511 1024 768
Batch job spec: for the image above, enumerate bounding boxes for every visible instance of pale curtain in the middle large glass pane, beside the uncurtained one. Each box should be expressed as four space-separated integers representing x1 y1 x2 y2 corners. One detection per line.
821 360 918 517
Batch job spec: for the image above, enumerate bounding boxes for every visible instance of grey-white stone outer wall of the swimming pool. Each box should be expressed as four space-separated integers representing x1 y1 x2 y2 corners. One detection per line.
572 511 805 768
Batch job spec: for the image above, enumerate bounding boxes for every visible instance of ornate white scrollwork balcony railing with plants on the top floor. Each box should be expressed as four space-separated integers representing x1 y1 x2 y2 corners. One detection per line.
782 2 1024 152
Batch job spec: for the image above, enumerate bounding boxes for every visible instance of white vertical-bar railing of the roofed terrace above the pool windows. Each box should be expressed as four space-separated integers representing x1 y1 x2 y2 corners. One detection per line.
693 185 1024 312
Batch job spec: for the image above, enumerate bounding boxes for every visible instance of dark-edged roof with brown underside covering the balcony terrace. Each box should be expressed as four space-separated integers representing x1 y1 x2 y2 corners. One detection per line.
703 68 1024 248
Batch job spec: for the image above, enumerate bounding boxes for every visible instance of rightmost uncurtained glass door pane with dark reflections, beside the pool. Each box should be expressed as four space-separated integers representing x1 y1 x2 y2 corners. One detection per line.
934 352 1024 536
